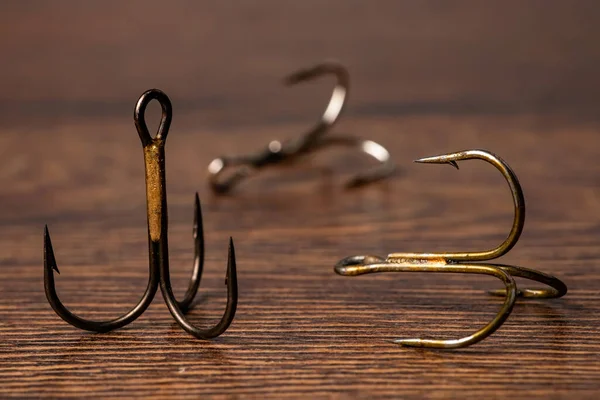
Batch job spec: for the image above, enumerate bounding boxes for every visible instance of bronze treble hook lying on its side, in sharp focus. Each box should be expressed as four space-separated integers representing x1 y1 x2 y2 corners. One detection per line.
334 150 567 349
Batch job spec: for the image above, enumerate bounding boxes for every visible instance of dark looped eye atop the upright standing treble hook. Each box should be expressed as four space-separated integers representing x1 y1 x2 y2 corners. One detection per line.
133 89 173 147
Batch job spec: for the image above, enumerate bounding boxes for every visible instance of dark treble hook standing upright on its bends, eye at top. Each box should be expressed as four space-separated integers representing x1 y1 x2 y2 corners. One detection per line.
44 89 238 339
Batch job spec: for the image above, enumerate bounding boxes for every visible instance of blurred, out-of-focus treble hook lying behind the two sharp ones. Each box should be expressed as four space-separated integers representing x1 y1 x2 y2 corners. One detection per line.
208 61 395 193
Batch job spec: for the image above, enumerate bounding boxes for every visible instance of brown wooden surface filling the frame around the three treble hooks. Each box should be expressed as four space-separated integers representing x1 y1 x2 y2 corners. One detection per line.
0 1 600 398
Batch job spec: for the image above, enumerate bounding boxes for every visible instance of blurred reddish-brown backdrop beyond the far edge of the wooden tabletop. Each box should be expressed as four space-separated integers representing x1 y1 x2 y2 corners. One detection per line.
0 0 600 127
